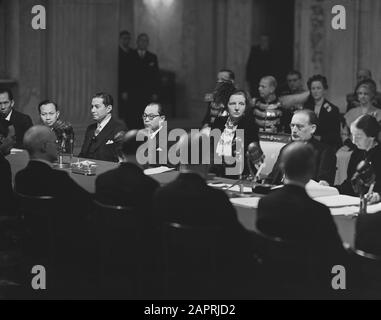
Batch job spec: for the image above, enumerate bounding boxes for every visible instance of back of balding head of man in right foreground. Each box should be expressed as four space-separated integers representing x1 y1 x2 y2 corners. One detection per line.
280 142 316 184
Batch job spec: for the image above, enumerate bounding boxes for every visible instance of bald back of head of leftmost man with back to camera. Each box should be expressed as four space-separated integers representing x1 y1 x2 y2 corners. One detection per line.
24 126 57 162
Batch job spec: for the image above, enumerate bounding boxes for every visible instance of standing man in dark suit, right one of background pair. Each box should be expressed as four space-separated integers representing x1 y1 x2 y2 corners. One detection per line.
127 33 159 129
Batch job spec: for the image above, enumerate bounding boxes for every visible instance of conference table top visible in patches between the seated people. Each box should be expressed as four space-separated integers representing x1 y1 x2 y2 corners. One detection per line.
7 150 356 245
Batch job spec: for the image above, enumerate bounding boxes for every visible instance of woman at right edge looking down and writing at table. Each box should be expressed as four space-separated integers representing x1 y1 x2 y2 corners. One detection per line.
338 115 381 203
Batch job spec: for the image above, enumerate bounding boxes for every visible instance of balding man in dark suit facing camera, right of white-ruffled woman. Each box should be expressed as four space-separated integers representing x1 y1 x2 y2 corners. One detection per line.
266 110 336 186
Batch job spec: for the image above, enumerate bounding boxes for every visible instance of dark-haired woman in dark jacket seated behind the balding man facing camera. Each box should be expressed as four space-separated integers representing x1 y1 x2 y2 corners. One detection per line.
304 75 341 150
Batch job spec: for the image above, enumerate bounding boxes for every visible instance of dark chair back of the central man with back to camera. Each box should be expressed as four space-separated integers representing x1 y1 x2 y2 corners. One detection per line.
163 223 224 299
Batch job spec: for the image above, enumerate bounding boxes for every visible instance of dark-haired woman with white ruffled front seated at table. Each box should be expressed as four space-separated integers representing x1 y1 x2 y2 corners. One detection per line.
212 90 259 178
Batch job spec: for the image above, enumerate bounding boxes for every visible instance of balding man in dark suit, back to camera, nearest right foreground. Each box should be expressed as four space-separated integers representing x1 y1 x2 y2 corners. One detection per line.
256 142 346 294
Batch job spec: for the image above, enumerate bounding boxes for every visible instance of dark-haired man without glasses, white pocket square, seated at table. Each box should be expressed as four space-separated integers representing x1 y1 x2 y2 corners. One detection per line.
79 92 125 162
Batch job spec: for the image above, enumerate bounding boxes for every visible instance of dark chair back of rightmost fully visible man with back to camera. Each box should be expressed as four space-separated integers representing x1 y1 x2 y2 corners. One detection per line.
252 230 331 299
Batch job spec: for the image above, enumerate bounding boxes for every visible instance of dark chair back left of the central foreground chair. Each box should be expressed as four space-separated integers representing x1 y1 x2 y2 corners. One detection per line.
95 202 148 299
